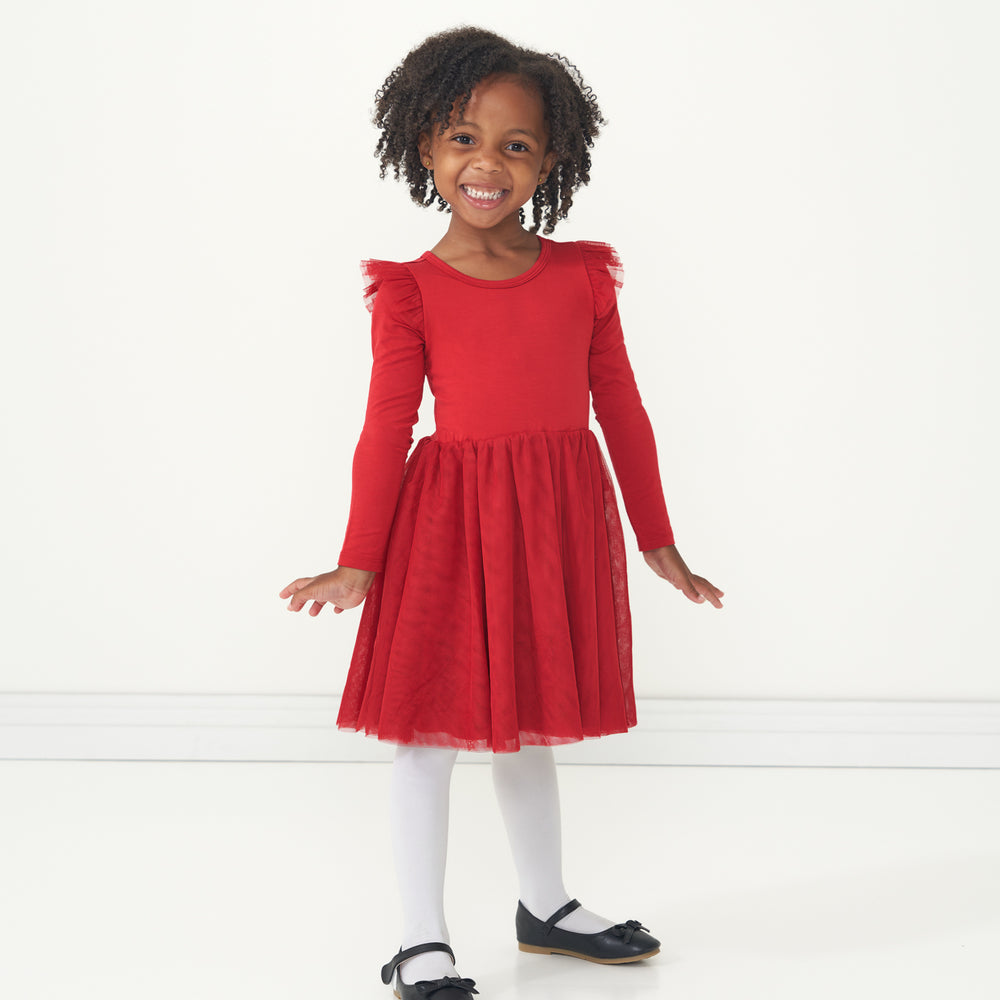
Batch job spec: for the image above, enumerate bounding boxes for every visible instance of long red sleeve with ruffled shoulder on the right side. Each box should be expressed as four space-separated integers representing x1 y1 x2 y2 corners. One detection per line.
580 243 674 552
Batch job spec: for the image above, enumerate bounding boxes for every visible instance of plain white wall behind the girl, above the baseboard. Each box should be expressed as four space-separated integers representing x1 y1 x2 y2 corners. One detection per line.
0 0 1000 700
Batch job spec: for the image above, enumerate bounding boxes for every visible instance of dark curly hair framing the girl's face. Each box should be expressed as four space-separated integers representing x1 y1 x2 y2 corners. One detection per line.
373 27 606 235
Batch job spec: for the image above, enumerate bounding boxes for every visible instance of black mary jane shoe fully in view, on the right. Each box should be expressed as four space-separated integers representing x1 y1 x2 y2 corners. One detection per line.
517 899 660 965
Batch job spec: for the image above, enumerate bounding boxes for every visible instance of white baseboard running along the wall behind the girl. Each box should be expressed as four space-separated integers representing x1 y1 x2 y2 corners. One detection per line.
0 693 1000 768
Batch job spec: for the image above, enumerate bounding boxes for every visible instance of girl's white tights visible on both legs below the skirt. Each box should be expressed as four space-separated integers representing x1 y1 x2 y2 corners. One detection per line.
389 746 612 983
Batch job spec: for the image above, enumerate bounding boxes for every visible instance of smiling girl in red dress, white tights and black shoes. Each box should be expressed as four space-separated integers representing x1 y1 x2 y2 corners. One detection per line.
281 28 722 1000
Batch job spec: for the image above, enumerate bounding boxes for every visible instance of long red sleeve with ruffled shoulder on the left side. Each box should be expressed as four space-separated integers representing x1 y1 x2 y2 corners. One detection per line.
338 260 425 572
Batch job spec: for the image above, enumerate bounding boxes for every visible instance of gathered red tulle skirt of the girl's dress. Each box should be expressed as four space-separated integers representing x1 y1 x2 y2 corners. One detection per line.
338 428 636 753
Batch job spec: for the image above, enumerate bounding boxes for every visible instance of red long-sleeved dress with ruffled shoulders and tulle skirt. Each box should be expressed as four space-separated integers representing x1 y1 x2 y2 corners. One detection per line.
337 239 673 753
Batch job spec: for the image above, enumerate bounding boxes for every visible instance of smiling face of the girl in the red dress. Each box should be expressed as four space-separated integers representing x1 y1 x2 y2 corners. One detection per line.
420 76 555 237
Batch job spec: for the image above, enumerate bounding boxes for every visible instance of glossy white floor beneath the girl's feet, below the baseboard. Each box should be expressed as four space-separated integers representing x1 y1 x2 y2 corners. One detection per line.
0 761 1000 1000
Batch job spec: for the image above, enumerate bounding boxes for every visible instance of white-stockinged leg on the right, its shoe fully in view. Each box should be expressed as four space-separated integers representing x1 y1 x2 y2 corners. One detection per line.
493 747 614 934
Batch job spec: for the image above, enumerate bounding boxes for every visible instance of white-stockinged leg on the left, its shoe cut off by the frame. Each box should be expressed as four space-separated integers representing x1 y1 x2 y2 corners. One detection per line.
389 746 458 984
